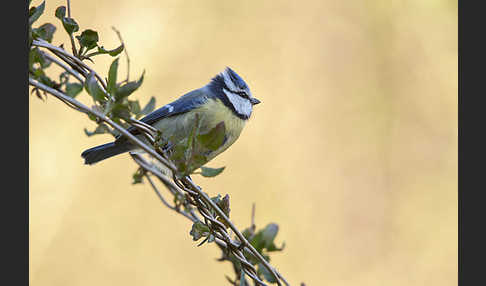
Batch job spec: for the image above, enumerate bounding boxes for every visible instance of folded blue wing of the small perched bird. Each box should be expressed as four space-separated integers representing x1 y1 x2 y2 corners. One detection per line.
121 88 208 139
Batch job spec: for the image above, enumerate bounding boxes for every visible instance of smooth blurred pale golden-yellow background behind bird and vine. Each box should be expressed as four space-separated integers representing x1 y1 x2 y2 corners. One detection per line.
29 0 458 286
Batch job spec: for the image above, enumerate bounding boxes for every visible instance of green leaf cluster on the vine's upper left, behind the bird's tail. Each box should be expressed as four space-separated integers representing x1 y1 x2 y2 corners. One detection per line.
29 1 155 136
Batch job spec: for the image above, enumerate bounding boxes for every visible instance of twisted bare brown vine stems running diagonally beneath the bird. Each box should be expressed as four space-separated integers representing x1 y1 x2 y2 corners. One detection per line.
29 40 289 286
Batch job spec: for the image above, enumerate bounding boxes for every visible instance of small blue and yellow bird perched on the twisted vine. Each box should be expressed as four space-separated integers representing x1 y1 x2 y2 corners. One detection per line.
81 67 260 172
